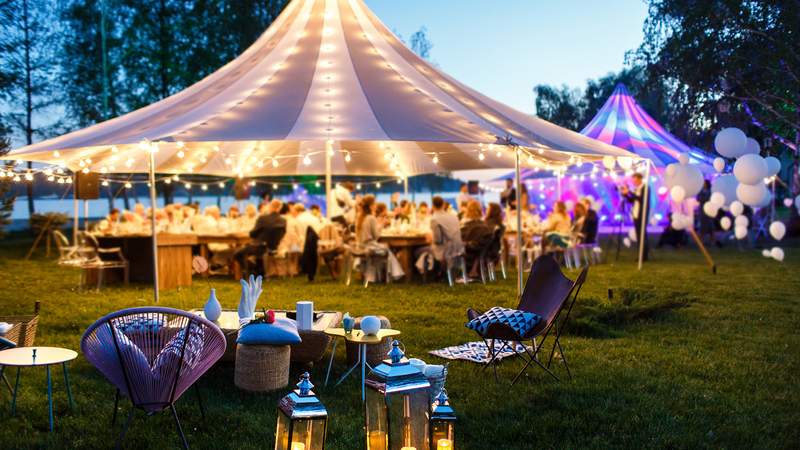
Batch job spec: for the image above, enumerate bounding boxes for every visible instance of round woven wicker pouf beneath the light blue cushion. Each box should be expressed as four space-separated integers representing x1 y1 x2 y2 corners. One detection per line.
233 344 291 392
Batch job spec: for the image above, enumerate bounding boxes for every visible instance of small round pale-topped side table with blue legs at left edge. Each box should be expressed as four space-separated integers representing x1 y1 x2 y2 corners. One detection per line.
0 347 78 431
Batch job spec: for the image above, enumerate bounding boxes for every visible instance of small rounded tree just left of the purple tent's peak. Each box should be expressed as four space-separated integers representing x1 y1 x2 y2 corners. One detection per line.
533 84 586 130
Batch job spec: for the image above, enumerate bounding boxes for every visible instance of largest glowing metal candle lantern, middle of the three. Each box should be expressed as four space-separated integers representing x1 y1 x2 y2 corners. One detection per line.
365 341 431 450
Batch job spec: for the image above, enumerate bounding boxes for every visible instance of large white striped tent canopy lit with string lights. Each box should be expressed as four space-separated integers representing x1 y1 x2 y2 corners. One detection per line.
7 0 635 176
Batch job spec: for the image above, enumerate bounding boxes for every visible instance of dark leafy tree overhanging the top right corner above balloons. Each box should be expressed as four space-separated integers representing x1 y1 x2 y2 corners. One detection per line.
636 0 800 152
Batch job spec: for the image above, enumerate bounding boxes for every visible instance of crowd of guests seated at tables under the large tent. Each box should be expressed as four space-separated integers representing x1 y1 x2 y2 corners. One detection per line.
96 178 598 280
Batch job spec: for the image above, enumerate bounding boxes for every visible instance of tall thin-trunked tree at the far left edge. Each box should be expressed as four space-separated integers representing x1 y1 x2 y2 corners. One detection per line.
0 0 59 214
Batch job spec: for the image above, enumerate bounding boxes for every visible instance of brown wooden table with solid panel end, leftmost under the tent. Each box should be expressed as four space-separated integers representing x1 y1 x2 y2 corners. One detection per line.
97 233 198 289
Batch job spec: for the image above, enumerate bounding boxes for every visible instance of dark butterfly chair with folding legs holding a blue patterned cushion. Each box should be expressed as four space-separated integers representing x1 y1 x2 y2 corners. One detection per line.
467 255 589 384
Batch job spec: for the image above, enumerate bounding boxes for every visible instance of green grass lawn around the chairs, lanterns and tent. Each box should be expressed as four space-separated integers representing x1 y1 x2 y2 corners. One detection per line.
0 234 800 450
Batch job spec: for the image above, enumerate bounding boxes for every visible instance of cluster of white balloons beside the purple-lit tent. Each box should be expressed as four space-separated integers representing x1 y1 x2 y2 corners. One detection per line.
703 128 784 261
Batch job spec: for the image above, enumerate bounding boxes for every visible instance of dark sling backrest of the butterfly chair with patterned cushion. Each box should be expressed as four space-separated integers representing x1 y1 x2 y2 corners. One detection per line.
517 255 586 326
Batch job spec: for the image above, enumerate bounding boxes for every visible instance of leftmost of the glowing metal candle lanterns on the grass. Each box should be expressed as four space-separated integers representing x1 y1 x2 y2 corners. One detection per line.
275 372 328 450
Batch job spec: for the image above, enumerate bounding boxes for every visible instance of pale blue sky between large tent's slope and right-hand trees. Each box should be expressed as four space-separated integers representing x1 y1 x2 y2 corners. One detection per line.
365 0 647 113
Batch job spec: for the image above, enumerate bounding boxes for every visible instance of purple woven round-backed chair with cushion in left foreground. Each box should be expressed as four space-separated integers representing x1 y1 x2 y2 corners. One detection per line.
81 307 225 448
